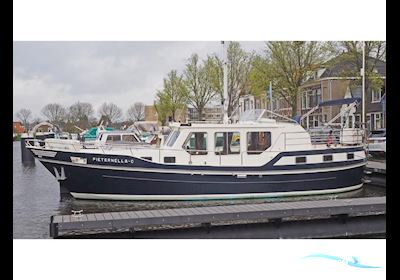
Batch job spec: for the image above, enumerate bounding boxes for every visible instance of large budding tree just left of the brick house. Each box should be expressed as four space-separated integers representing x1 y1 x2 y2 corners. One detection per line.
266 41 331 117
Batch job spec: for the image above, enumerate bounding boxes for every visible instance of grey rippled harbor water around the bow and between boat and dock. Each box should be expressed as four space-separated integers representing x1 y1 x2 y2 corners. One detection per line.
13 142 386 238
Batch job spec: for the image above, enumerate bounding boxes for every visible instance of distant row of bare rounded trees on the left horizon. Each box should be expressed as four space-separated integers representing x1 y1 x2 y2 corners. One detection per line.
16 101 145 132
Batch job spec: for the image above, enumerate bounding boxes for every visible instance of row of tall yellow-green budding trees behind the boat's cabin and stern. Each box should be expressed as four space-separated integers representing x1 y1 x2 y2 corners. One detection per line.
154 41 386 123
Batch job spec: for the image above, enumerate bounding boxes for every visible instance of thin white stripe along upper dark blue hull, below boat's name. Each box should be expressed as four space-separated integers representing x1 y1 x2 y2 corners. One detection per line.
38 158 366 176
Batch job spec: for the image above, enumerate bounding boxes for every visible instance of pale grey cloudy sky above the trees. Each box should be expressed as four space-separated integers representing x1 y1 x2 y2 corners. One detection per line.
13 41 265 118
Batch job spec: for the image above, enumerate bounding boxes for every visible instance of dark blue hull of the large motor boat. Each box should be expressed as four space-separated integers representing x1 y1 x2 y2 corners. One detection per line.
32 144 365 200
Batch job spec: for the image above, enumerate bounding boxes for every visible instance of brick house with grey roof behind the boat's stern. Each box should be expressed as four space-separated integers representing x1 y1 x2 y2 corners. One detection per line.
297 55 386 130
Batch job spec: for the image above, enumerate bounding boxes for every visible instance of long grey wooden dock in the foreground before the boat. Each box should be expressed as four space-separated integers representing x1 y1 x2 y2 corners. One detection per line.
50 197 386 238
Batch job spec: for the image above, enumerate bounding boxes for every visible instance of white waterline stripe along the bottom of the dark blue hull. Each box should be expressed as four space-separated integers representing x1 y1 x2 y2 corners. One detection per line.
71 184 363 200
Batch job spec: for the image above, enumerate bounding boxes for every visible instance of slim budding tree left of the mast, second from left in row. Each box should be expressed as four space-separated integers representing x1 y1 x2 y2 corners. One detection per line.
184 54 216 120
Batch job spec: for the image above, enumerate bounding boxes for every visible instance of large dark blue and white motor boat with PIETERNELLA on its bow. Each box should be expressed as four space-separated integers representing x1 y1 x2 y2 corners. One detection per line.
27 110 366 200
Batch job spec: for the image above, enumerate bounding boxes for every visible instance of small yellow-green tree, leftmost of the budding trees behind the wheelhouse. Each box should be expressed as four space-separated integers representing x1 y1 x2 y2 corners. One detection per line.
155 70 187 122
